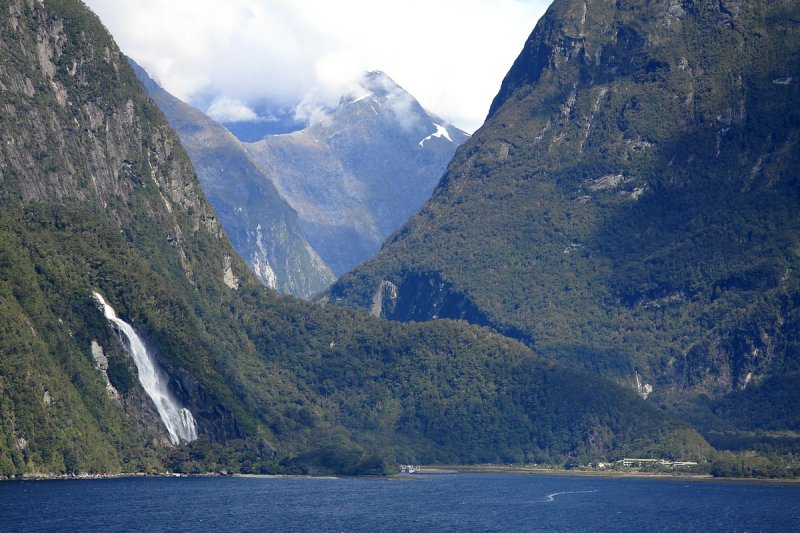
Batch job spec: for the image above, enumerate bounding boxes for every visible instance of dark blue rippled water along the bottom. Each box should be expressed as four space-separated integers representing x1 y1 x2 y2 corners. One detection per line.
0 474 800 533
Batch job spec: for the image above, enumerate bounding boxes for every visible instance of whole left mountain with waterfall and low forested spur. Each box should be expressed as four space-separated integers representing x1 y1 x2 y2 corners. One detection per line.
0 0 711 477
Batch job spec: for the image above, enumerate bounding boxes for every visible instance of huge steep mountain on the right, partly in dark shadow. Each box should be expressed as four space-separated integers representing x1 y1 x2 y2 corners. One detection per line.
328 0 800 436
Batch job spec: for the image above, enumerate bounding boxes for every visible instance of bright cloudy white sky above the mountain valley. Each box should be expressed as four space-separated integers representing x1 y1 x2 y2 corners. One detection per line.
84 0 551 133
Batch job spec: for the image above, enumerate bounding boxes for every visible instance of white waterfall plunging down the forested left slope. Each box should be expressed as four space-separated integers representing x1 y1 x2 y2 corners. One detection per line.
92 292 197 444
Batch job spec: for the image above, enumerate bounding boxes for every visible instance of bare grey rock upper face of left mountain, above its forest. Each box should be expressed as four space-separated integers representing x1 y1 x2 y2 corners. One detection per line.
0 2 220 233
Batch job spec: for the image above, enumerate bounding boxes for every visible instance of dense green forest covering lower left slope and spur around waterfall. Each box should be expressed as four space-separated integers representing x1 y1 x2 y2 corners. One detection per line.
0 201 708 475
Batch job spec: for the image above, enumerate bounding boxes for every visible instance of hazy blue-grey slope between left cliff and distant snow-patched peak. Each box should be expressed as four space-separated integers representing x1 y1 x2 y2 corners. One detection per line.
128 59 335 298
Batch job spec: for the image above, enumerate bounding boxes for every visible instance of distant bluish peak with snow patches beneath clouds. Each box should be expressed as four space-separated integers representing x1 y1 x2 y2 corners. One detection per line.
245 72 468 275
